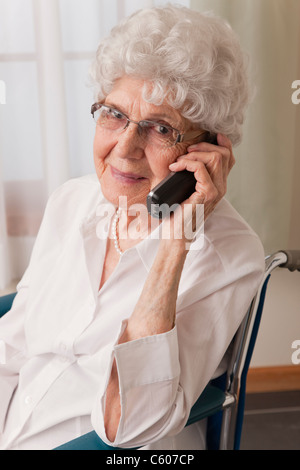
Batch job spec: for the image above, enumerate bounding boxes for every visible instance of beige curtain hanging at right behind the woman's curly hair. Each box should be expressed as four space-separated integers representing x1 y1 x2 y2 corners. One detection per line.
191 0 300 253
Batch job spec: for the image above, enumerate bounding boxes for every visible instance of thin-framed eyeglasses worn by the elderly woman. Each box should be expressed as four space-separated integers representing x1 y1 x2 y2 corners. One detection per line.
91 103 206 147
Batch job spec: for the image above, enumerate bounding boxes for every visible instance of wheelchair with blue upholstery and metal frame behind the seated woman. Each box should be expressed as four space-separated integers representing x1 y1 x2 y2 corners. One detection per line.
0 250 300 451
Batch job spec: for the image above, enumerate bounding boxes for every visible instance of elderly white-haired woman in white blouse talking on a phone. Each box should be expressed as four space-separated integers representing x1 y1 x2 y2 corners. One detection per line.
0 6 264 449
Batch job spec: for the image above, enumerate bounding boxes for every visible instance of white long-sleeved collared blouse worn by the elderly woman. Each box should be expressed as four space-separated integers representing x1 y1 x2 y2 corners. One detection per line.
0 175 264 450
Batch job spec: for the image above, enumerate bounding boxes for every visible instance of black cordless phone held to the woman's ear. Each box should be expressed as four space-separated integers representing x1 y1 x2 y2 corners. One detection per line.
147 136 217 219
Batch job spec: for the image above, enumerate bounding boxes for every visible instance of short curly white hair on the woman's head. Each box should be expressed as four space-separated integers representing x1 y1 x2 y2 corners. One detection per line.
90 5 252 145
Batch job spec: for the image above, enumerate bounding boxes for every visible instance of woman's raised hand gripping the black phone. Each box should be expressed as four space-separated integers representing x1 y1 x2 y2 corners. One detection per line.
169 134 235 219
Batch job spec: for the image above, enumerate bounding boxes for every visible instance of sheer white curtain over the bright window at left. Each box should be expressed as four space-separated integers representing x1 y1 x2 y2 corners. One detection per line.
0 0 190 290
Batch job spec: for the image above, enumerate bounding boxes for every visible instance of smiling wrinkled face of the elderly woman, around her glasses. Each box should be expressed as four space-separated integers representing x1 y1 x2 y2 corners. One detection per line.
94 76 192 207
